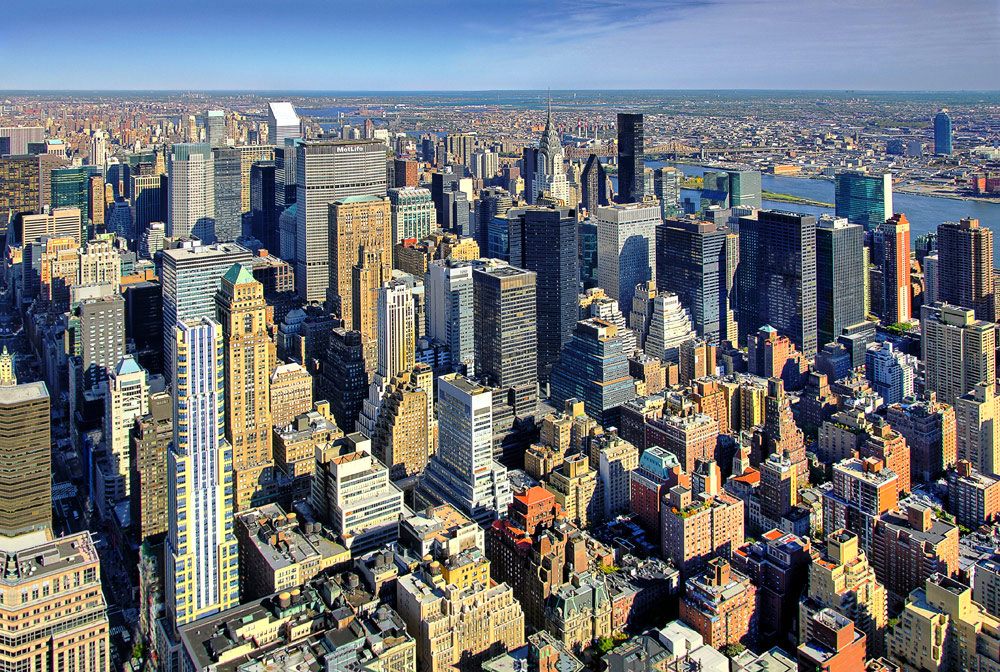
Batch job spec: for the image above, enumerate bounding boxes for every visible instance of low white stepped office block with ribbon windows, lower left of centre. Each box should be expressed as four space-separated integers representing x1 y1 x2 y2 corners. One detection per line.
311 433 403 557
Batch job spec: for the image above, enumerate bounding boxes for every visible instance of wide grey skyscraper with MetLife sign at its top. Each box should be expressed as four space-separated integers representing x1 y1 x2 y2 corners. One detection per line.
295 140 392 301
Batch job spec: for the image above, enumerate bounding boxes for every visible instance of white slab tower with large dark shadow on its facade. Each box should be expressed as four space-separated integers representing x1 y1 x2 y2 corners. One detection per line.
597 201 662 309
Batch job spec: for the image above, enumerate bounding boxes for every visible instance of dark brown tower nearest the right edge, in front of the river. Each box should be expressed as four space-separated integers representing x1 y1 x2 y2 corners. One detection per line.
937 219 996 322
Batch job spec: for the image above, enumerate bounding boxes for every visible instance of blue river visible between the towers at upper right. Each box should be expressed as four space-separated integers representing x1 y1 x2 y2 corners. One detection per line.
646 161 1000 265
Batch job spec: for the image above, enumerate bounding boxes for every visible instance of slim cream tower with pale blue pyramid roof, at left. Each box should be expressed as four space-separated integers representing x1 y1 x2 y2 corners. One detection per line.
102 356 149 502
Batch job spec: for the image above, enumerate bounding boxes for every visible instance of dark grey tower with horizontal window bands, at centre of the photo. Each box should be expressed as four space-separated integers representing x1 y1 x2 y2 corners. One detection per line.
472 264 538 418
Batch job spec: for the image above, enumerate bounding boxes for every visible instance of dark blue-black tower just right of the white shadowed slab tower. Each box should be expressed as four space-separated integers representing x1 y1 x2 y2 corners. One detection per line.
656 219 735 344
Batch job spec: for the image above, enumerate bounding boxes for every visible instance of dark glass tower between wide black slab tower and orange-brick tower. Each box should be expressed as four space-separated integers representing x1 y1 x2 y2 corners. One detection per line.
816 215 868 345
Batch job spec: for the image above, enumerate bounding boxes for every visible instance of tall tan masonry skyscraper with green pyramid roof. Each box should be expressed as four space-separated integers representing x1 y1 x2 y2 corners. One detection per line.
215 263 274 513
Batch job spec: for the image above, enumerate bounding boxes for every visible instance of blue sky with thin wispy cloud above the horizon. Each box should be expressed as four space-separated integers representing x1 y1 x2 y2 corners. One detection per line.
0 0 1000 91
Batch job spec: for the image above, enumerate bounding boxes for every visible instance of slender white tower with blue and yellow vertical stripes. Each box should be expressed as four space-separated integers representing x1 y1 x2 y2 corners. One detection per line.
165 317 239 626
